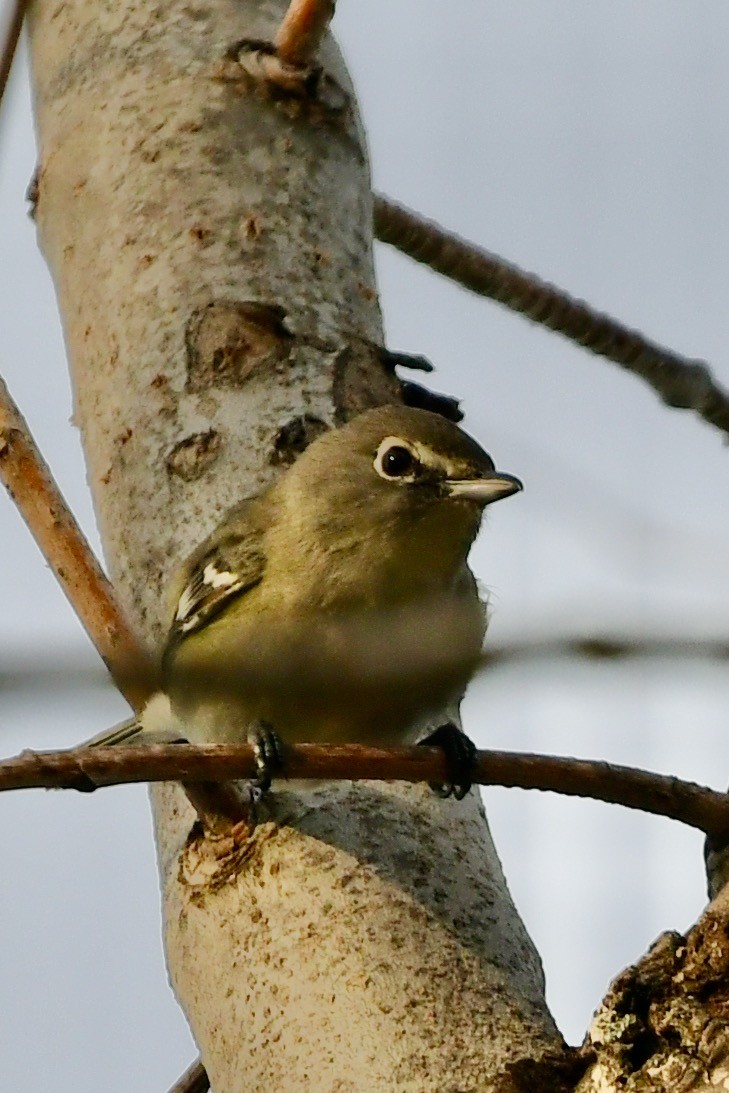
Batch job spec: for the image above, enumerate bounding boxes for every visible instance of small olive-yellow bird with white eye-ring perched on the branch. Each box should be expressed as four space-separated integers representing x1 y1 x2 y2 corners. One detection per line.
96 406 521 797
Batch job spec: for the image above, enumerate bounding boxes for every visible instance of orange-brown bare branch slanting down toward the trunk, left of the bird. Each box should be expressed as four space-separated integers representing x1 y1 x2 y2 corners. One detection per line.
0 379 153 709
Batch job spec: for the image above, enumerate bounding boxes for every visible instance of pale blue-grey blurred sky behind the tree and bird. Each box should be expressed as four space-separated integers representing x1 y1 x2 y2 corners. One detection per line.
0 0 729 1093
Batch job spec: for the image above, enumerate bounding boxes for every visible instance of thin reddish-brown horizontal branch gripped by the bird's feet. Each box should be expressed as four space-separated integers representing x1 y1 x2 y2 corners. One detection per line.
0 744 729 837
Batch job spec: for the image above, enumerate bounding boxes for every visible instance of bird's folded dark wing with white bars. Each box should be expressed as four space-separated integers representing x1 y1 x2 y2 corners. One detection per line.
169 498 266 643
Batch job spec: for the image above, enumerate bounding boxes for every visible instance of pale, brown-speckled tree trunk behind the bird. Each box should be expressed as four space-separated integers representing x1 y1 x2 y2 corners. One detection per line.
32 0 561 1093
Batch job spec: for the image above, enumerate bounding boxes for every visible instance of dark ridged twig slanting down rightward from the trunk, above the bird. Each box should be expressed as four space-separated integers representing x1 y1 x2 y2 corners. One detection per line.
375 195 729 435
